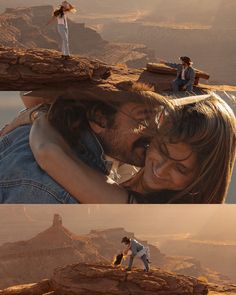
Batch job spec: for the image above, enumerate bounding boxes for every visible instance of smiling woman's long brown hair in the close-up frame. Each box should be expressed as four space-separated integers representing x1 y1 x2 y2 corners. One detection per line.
149 94 236 204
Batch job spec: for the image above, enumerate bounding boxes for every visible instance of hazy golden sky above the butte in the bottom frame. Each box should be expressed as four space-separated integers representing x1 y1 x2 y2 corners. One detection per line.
0 205 236 244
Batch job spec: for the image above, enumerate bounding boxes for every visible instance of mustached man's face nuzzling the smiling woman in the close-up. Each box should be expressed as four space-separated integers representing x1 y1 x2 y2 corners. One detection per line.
99 102 155 167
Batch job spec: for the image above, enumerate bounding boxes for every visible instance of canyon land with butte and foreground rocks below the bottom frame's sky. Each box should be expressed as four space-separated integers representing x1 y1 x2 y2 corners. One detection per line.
0 209 236 295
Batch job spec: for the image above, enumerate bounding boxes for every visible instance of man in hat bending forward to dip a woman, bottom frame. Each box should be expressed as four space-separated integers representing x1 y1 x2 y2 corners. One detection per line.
121 237 149 272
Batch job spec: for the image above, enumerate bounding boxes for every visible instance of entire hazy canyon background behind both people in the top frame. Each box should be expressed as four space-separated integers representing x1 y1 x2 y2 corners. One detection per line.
0 0 236 85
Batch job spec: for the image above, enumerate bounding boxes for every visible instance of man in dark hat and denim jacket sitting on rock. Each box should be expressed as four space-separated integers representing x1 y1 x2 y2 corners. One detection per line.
162 56 196 93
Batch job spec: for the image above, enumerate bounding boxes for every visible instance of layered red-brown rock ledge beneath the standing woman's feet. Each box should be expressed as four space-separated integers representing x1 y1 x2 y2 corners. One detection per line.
0 47 110 90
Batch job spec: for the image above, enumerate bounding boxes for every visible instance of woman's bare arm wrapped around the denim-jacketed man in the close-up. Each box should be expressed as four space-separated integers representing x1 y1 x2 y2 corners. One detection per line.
30 116 131 204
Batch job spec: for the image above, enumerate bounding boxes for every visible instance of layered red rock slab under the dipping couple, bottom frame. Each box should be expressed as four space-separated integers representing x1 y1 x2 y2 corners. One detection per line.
51 264 207 295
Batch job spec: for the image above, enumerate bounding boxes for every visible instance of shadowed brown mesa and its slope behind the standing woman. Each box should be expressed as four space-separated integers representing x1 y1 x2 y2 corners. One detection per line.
0 5 153 67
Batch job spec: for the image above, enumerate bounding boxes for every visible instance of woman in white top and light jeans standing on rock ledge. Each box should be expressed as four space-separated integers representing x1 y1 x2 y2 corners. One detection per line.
46 1 76 59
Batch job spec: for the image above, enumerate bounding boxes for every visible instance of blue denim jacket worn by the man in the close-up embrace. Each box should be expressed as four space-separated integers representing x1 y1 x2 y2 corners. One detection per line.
0 125 109 204
